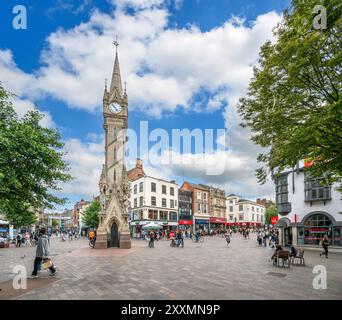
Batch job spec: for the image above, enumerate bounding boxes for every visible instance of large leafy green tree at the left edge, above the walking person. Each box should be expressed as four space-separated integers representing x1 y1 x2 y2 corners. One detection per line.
0 83 71 227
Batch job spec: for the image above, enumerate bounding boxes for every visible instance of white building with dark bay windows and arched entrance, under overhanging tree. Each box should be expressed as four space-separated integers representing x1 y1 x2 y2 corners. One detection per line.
275 161 342 246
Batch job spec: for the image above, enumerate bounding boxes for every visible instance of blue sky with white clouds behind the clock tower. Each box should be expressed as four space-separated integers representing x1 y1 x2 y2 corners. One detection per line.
0 0 289 209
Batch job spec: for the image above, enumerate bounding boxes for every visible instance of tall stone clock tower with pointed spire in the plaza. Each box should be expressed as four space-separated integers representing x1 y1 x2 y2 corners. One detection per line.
95 41 131 249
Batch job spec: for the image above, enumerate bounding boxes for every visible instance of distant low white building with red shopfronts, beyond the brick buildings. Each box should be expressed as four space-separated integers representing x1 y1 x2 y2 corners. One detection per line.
226 194 266 227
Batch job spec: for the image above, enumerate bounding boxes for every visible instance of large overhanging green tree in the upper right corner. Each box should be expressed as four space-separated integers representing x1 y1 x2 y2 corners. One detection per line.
239 0 342 189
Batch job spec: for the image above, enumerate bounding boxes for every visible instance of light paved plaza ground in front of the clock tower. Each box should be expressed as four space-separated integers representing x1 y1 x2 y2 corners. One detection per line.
0 235 342 300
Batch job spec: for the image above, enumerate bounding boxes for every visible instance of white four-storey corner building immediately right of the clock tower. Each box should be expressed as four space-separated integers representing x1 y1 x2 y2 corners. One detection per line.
129 175 178 238
